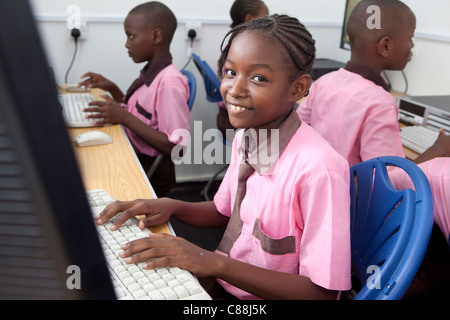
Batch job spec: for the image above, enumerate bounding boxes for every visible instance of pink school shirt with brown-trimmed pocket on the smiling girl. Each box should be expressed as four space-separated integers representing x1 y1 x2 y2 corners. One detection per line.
214 123 351 299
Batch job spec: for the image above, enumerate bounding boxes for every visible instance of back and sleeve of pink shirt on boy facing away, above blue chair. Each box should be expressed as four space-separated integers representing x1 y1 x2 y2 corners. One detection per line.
297 69 404 166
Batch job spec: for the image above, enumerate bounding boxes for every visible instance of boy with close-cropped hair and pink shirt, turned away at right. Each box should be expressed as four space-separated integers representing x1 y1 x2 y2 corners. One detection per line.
297 0 450 298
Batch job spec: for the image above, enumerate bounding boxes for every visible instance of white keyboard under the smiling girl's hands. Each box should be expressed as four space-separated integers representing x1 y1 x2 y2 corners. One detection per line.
87 189 211 300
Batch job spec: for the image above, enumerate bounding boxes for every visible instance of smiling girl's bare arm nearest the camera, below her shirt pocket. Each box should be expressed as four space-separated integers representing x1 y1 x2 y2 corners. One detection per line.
121 234 337 300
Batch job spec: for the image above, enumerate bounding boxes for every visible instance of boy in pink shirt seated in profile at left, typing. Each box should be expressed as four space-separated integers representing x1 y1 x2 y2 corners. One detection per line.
79 1 190 197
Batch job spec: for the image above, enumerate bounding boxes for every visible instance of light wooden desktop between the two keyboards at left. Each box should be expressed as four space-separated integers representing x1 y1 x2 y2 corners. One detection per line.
69 89 171 233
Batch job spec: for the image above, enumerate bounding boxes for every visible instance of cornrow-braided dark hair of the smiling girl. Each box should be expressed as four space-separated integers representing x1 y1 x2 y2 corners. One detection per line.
218 14 316 79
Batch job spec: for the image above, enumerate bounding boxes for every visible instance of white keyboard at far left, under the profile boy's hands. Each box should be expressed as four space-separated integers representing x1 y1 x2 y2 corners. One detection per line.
58 93 98 128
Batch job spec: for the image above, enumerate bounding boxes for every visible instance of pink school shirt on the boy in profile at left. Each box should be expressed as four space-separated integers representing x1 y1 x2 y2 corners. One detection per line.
121 64 190 157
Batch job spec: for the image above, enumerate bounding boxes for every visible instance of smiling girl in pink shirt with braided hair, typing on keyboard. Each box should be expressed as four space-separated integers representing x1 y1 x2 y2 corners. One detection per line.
97 15 351 299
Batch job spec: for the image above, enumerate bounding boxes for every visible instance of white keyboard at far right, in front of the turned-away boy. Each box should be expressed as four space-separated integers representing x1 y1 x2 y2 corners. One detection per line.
400 126 439 154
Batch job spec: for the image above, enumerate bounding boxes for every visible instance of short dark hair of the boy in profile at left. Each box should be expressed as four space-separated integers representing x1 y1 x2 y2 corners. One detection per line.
128 1 178 43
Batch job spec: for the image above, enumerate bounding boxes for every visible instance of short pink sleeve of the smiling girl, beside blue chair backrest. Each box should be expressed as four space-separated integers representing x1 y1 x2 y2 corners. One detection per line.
299 171 351 290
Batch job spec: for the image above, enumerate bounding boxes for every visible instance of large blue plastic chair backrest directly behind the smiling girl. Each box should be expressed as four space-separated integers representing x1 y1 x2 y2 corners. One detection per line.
350 157 433 300
